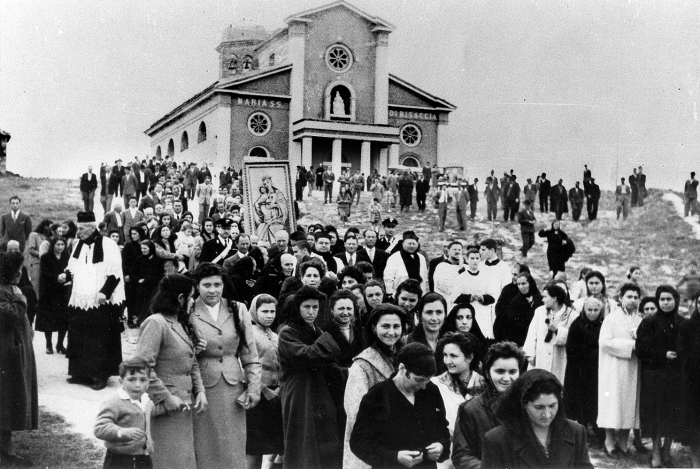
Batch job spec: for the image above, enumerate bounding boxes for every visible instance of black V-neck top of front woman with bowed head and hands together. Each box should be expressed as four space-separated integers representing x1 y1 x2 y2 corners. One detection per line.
350 373 450 468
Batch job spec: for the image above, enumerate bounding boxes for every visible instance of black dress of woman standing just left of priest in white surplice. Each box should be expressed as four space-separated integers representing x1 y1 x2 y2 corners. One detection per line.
36 249 71 332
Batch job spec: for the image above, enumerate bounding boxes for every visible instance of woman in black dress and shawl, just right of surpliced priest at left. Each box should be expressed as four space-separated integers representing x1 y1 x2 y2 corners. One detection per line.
131 239 163 325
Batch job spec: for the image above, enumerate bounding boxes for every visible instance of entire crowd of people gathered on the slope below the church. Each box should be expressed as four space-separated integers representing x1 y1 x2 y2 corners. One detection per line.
0 159 700 469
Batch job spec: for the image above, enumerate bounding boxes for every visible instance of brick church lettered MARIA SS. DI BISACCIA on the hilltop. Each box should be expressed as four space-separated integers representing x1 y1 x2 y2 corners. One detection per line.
145 0 455 181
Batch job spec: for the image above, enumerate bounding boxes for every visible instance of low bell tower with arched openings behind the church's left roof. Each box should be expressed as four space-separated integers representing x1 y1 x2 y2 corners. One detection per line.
216 25 269 78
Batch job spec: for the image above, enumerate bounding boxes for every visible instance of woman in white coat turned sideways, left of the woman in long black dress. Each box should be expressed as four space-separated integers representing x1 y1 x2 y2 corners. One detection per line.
523 283 578 382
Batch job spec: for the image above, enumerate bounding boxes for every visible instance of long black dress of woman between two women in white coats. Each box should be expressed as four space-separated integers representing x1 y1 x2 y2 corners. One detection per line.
564 312 603 425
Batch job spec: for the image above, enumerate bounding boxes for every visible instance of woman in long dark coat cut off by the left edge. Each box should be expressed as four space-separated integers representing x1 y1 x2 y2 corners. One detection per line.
0 252 39 467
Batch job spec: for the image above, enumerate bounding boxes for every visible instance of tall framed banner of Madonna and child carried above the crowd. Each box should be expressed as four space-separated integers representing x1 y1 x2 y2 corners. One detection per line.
243 157 296 245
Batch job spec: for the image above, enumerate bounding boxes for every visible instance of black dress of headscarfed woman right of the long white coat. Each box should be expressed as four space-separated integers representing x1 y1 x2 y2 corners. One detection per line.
636 311 684 439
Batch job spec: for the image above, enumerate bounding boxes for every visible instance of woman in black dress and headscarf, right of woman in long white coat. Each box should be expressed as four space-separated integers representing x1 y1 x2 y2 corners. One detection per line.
635 285 684 467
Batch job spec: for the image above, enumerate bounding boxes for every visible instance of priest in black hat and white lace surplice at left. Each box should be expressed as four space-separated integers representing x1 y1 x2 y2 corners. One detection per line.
64 212 125 390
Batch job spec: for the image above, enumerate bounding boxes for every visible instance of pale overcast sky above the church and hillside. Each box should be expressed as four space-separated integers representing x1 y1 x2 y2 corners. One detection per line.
0 0 700 189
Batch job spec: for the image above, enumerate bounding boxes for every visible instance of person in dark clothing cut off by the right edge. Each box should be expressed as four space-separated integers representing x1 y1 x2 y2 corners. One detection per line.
676 295 700 467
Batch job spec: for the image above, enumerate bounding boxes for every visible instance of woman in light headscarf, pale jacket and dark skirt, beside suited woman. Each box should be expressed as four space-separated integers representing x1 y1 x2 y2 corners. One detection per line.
246 293 284 469
